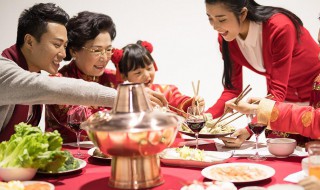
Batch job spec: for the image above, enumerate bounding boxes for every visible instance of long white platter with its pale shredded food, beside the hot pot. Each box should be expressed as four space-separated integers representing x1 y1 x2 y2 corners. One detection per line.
159 146 232 168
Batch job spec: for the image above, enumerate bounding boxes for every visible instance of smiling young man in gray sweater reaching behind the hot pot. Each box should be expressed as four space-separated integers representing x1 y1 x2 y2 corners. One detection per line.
0 3 167 142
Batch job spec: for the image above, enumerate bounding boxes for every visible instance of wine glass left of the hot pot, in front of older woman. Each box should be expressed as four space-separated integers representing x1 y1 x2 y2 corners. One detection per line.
67 106 87 158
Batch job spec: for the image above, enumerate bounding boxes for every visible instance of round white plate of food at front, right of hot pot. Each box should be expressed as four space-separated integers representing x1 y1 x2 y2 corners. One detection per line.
201 163 276 183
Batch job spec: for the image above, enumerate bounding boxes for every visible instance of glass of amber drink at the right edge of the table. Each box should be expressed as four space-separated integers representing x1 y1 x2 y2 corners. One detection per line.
308 144 320 179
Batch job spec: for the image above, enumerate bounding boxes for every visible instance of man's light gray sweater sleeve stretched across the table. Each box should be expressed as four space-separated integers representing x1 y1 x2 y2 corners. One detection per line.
0 57 117 107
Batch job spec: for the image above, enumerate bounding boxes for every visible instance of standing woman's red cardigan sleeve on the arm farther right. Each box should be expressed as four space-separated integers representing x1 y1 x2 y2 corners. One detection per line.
263 14 297 101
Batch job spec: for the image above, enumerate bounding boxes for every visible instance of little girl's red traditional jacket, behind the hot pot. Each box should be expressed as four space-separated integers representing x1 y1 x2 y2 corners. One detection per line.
150 84 193 115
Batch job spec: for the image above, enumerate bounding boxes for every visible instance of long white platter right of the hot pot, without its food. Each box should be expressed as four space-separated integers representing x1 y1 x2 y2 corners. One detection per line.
159 148 232 168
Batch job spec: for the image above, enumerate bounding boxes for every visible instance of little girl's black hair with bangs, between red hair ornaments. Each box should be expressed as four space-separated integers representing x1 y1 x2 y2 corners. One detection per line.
119 40 154 77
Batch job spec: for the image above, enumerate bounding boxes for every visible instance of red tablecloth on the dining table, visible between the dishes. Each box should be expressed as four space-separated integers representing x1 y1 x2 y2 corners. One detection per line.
33 137 304 190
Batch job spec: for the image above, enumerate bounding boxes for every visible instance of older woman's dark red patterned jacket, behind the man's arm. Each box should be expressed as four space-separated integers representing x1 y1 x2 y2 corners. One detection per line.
45 61 118 143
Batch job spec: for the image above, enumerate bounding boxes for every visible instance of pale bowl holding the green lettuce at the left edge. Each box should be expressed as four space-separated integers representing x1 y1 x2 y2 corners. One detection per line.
0 168 38 181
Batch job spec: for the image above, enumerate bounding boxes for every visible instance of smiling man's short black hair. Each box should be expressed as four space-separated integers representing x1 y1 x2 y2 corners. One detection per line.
16 3 69 48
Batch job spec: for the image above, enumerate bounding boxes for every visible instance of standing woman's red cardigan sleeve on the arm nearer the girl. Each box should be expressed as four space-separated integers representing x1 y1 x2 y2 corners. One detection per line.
206 35 242 118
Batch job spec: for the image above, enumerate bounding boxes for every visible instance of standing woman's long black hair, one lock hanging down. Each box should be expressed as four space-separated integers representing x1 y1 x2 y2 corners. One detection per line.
205 0 303 89
